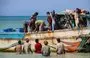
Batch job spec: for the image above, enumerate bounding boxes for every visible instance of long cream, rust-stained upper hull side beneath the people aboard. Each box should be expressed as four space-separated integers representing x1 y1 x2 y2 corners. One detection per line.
24 29 90 39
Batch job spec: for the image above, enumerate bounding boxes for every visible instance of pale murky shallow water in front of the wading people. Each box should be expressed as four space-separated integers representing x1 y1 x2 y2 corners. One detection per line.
0 53 90 58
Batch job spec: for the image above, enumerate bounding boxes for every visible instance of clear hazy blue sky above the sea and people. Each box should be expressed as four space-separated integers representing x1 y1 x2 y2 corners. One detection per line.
0 0 90 16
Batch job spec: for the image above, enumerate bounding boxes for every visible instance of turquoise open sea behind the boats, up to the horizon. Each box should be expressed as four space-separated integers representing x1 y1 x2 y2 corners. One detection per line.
0 16 46 31
